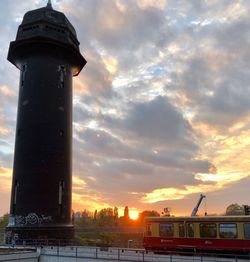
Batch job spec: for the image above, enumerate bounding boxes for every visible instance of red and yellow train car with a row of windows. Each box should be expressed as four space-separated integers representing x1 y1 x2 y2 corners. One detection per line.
143 216 250 253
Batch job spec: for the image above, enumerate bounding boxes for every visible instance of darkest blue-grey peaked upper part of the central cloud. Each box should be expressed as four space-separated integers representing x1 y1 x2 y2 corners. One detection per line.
118 97 192 146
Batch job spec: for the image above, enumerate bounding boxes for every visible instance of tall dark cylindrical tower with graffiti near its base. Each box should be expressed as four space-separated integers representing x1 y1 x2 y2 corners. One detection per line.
6 1 86 241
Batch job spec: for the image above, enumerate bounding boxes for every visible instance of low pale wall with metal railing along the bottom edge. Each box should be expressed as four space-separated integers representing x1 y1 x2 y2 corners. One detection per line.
40 246 250 262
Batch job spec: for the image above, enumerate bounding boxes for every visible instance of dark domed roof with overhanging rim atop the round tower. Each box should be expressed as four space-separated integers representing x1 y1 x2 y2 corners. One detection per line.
8 0 86 75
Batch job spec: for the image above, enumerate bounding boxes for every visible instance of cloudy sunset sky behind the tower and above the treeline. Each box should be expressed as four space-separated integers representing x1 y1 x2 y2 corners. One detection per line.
0 0 250 215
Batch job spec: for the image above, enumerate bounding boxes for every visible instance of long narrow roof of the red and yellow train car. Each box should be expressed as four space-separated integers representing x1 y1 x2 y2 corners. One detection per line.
145 216 250 223
